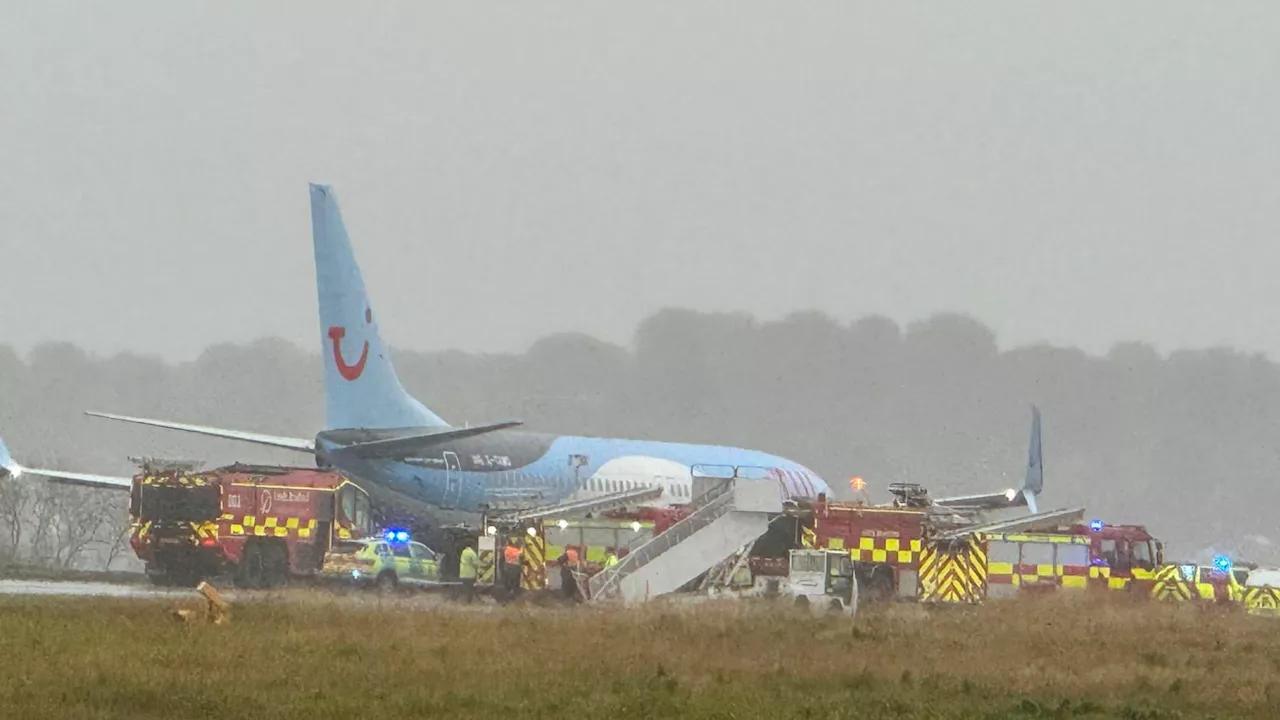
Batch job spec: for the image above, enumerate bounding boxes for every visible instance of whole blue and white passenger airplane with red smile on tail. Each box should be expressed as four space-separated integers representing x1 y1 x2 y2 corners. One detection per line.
6 183 1021 514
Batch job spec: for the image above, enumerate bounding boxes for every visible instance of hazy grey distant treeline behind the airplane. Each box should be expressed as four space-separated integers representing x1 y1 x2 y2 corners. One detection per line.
0 310 1280 561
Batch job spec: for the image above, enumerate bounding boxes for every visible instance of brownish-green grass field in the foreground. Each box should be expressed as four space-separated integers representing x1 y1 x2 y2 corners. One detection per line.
0 593 1280 720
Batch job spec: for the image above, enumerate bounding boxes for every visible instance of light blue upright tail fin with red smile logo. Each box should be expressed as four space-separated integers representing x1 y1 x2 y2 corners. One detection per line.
311 183 448 429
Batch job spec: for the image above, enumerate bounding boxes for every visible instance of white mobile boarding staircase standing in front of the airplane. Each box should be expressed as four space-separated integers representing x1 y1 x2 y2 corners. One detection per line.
585 466 783 603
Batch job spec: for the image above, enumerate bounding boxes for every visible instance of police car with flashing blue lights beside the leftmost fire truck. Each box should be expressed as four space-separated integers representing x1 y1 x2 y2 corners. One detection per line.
320 529 444 592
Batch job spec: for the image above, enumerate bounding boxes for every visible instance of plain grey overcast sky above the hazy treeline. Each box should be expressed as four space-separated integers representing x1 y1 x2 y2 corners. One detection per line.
0 0 1280 359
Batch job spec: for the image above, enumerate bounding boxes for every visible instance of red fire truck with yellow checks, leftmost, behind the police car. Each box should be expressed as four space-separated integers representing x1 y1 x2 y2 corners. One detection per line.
129 464 372 588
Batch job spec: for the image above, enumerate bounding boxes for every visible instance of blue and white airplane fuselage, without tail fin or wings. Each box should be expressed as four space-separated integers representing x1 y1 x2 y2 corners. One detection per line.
316 429 829 512
